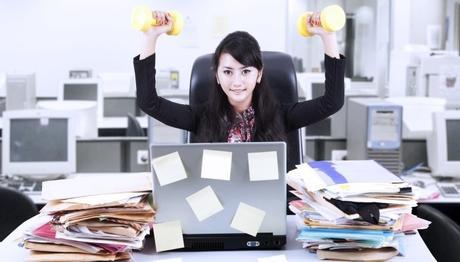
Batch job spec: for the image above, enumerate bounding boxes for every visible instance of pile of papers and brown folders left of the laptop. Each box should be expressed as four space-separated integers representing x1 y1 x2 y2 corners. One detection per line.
19 173 154 261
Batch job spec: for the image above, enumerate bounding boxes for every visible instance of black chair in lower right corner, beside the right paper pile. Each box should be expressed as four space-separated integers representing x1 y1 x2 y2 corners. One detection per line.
417 205 460 262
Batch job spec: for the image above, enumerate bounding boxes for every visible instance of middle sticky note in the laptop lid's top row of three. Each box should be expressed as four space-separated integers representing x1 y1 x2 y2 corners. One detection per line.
201 149 232 180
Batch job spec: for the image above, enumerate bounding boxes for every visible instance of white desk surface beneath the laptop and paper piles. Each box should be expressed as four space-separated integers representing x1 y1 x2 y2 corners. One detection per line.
0 216 436 262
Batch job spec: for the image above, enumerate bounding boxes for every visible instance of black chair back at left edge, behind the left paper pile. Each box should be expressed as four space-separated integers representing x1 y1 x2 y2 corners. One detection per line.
0 186 38 241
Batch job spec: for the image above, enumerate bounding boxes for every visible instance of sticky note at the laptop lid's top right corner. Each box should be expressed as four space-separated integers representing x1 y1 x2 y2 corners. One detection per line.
248 151 279 181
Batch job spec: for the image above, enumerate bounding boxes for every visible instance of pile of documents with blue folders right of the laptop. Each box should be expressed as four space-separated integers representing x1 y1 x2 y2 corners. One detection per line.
287 160 430 261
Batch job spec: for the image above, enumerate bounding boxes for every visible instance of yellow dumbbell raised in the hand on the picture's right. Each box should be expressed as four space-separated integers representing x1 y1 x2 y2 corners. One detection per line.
297 5 345 37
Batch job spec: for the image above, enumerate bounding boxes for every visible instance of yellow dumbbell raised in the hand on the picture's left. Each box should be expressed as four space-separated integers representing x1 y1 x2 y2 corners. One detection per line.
131 6 184 35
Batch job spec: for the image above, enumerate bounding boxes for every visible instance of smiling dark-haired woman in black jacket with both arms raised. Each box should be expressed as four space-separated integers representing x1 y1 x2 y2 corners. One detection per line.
134 11 345 145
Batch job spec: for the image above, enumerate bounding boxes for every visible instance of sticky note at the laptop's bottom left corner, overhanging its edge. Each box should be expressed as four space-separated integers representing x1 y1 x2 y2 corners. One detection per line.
153 220 184 252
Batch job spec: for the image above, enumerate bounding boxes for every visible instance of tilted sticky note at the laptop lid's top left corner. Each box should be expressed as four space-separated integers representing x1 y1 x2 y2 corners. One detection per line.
152 152 187 186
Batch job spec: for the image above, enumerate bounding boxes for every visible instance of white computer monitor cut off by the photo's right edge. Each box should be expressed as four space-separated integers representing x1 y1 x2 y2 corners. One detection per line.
427 110 460 178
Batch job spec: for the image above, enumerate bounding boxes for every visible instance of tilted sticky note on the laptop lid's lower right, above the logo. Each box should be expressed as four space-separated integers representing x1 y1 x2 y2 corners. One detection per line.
230 202 265 237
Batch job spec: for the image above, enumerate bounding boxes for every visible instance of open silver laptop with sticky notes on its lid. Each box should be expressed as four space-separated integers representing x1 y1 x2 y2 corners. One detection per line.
150 142 286 250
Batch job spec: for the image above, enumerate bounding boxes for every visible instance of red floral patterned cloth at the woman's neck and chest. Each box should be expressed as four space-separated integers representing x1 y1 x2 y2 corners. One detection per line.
227 106 255 143
